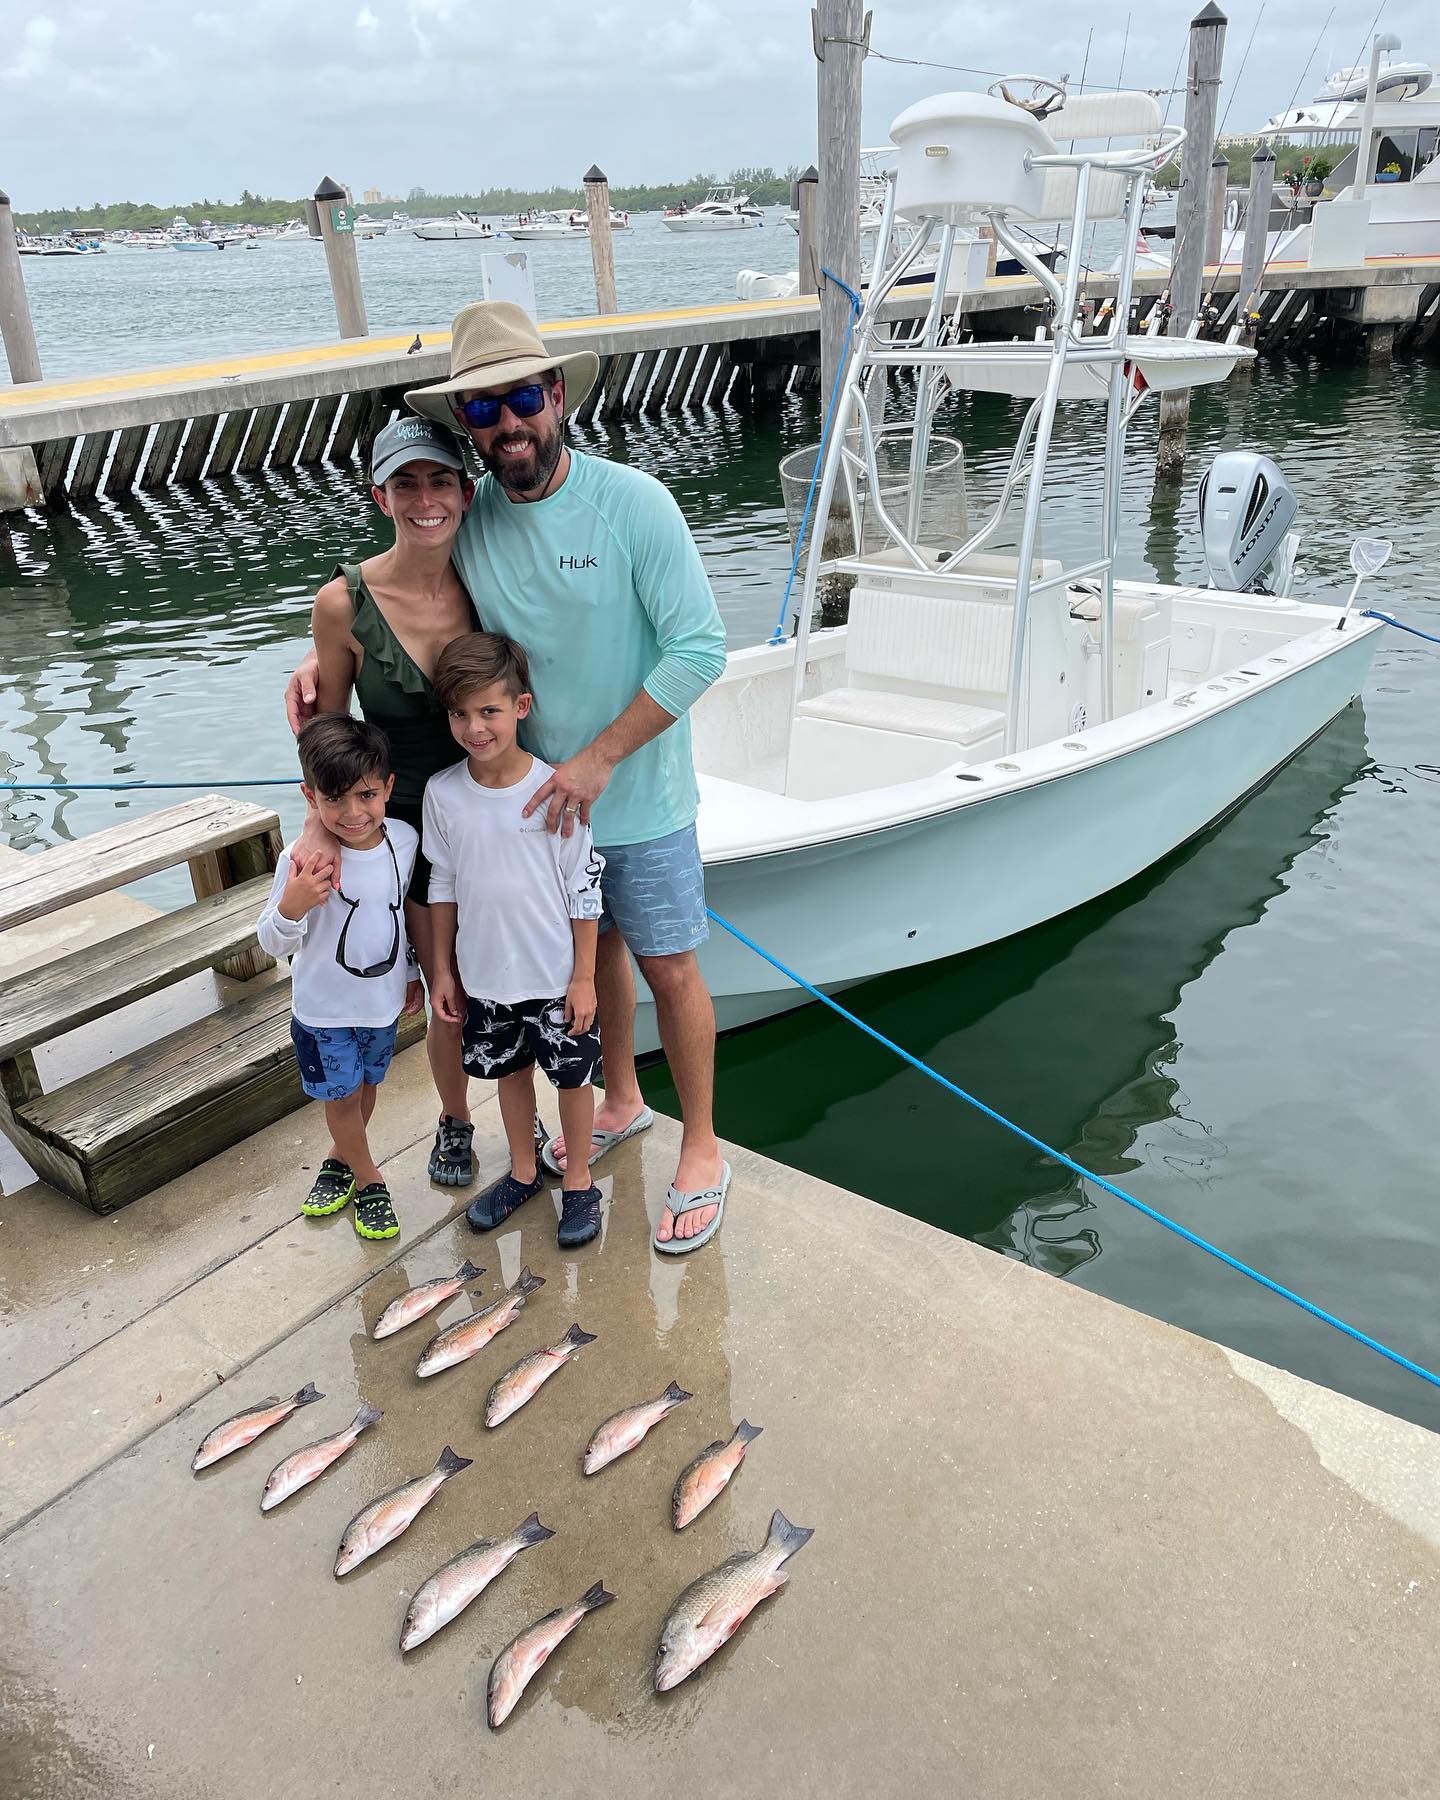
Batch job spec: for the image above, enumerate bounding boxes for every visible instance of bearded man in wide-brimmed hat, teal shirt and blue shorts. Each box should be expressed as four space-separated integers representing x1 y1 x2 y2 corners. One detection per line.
405 301 731 1255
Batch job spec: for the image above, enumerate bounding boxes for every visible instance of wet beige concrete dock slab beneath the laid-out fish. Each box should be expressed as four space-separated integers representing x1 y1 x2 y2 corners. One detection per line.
0 1120 1440 1800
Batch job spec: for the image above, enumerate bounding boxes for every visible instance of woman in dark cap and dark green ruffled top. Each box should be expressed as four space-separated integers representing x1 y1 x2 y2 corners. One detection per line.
284 418 481 1188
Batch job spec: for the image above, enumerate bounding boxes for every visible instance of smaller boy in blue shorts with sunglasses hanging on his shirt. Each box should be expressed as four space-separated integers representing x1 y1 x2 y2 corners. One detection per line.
256 713 425 1238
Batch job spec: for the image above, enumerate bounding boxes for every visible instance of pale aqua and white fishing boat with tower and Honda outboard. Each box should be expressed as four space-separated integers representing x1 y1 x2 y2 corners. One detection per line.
639 81 1388 1049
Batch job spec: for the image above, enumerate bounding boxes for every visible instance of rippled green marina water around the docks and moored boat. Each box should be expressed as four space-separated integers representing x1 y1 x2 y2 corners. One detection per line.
0 246 1440 1429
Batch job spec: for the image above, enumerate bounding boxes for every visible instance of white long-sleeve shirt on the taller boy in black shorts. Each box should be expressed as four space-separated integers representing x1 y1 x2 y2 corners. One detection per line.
423 756 605 1006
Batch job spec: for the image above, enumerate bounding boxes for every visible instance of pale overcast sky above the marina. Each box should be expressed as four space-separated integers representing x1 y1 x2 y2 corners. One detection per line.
0 0 1440 211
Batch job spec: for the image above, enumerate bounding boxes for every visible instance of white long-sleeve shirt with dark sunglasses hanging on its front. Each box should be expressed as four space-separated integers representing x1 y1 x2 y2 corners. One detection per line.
256 819 419 1028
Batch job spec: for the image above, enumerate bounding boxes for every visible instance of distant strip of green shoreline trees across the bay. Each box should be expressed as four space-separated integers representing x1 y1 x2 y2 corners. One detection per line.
14 164 799 234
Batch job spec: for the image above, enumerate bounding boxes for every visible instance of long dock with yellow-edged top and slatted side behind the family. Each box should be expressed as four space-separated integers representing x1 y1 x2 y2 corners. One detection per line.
0 257 1440 511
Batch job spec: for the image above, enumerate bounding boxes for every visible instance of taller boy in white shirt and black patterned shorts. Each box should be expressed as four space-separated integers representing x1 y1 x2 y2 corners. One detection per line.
423 632 605 1247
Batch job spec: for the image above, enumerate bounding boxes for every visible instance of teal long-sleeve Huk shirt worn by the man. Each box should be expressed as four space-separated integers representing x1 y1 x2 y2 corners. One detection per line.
454 450 725 850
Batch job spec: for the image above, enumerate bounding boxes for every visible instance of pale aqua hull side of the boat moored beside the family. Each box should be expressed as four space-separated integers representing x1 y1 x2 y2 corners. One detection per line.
635 619 1379 1053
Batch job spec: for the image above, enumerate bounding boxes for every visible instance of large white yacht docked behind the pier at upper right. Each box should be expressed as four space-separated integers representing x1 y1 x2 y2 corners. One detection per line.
1245 53 1440 266
